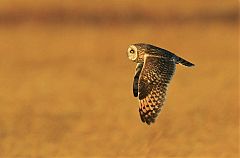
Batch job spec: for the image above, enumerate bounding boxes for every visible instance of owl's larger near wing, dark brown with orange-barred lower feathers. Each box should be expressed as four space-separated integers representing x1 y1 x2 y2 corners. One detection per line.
138 56 175 124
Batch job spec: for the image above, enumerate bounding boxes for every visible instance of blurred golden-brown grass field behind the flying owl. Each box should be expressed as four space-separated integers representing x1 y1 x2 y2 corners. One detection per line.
0 0 239 158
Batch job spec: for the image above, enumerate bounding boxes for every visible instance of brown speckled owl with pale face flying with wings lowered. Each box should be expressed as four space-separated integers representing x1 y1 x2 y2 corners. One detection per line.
127 43 194 124
